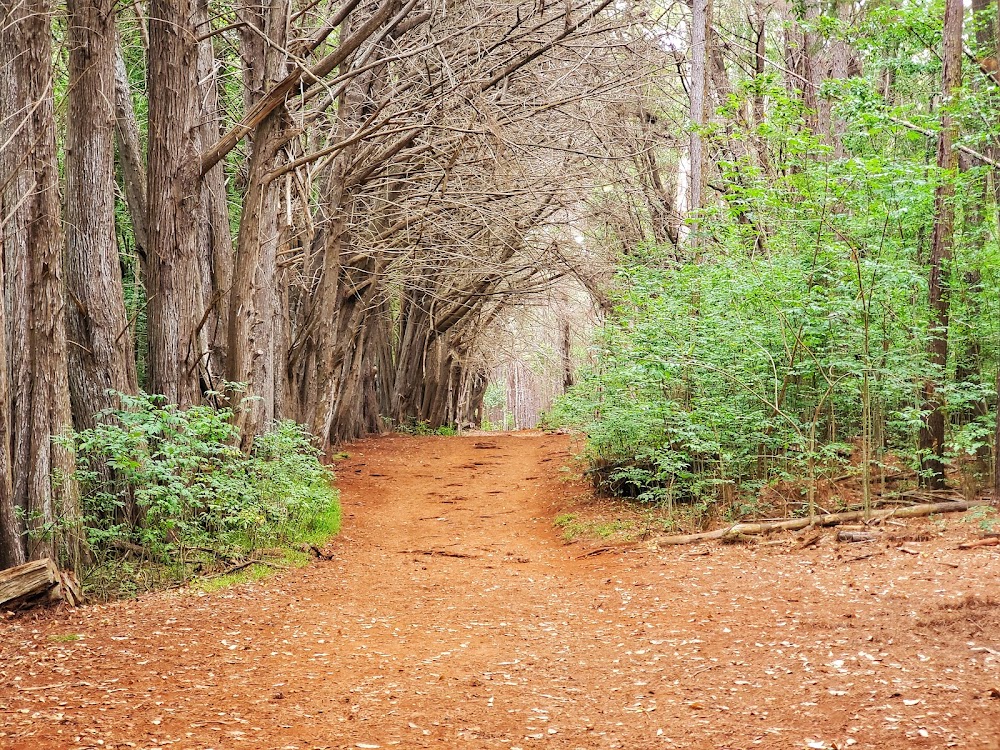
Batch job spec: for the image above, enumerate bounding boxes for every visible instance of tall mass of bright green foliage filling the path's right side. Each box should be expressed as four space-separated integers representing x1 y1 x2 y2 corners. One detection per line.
549 0 1000 514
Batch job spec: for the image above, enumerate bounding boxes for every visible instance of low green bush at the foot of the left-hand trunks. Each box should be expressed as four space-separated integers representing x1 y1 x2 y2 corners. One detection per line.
64 394 340 599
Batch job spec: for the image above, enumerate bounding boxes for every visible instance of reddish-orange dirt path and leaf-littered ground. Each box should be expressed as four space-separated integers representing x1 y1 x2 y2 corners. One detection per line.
0 433 1000 750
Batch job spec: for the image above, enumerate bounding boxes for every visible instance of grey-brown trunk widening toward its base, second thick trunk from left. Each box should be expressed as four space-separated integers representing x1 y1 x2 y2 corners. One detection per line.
66 0 137 428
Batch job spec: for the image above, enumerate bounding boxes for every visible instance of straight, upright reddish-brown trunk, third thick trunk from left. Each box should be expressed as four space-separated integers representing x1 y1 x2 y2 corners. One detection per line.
146 0 204 406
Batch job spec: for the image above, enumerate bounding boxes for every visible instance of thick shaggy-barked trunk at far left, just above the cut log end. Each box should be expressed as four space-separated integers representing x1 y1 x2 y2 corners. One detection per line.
0 0 79 565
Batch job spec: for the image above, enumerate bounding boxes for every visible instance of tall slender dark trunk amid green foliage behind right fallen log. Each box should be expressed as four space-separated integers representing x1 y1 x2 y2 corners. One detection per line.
920 0 964 489
